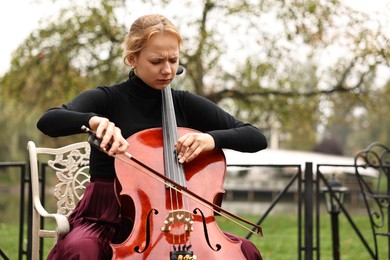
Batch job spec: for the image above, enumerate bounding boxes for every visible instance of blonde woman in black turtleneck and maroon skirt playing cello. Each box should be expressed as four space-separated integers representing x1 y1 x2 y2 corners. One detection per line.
37 15 267 259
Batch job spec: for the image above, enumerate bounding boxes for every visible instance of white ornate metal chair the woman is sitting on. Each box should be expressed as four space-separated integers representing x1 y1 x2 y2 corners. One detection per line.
27 141 90 259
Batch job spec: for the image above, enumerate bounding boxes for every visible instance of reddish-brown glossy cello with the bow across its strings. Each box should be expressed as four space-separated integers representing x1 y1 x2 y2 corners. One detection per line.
83 86 261 259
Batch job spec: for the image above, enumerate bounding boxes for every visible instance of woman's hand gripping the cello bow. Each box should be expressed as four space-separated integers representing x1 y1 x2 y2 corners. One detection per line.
89 116 129 156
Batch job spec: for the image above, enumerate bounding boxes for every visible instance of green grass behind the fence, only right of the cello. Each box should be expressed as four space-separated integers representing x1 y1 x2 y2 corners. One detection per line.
218 214 388 260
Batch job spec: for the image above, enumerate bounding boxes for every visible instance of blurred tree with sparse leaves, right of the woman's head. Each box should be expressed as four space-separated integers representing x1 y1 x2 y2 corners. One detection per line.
175 0 390 149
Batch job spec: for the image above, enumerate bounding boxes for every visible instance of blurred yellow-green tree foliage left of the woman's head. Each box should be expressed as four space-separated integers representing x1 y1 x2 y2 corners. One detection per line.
0 1 126 160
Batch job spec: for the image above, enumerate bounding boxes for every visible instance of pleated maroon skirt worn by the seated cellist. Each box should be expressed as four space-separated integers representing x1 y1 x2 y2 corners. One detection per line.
47 179 262 260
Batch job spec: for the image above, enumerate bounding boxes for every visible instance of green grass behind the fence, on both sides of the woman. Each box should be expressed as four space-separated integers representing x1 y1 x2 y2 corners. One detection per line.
0 214 388 260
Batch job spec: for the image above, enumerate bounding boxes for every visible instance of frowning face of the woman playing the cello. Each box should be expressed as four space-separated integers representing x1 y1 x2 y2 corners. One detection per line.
130 33 179 90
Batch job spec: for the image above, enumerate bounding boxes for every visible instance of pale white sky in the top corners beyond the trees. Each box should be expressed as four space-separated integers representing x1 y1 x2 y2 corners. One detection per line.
0 0 390 76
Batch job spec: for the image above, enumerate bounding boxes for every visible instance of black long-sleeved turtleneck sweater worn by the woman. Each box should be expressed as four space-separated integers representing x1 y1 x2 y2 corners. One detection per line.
37 72 267 179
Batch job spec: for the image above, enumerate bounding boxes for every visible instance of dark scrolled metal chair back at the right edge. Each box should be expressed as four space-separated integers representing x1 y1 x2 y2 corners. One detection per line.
355 142 390 259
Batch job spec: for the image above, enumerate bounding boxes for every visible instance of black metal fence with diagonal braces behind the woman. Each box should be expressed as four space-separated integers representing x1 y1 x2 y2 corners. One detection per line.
0 157 386 260
